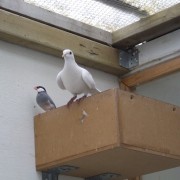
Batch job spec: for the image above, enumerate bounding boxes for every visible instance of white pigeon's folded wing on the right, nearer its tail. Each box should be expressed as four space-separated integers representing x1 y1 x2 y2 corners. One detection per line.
82 68 96 89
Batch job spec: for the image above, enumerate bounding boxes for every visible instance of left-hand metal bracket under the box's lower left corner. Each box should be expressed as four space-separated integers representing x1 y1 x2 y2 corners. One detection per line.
42 165 78 180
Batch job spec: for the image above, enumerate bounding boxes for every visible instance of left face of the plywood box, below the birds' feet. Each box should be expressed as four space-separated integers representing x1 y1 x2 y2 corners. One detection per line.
35 90 119 169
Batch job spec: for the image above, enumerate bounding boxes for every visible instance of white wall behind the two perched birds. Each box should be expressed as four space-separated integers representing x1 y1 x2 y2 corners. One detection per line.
0 41 118 180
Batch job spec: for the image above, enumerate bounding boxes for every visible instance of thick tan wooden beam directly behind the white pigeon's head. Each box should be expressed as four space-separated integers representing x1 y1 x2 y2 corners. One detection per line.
0 10 128 75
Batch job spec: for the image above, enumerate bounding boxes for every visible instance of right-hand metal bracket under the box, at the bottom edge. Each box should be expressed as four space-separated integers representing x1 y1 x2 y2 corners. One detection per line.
85 173 121 180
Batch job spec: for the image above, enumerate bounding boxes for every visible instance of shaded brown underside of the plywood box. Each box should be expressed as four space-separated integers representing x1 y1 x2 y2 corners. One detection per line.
47 148 180 180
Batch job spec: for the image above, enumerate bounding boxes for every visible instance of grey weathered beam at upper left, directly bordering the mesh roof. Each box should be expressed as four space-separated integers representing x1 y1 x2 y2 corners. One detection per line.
0 0 112 44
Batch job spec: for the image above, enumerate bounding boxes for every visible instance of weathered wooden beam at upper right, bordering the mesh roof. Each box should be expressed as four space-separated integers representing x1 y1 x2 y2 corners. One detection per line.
112 3 180 49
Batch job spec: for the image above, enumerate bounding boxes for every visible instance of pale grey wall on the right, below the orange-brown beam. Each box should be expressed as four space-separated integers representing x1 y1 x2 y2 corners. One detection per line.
135 72 180 180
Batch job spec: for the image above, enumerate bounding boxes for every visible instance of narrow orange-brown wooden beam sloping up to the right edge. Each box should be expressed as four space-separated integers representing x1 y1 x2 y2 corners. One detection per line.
121 56 180 88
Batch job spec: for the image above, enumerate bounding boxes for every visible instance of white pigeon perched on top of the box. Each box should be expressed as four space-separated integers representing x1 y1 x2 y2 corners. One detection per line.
56 49 100 105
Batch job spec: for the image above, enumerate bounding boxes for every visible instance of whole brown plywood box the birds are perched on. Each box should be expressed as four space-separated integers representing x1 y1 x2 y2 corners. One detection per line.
35 89 180 179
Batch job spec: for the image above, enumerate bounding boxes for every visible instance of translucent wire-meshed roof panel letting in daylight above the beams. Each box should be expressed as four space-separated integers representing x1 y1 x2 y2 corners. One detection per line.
24 0 180 32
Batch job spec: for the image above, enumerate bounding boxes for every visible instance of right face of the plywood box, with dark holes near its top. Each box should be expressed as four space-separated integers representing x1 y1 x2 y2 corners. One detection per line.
119 91 180 158
